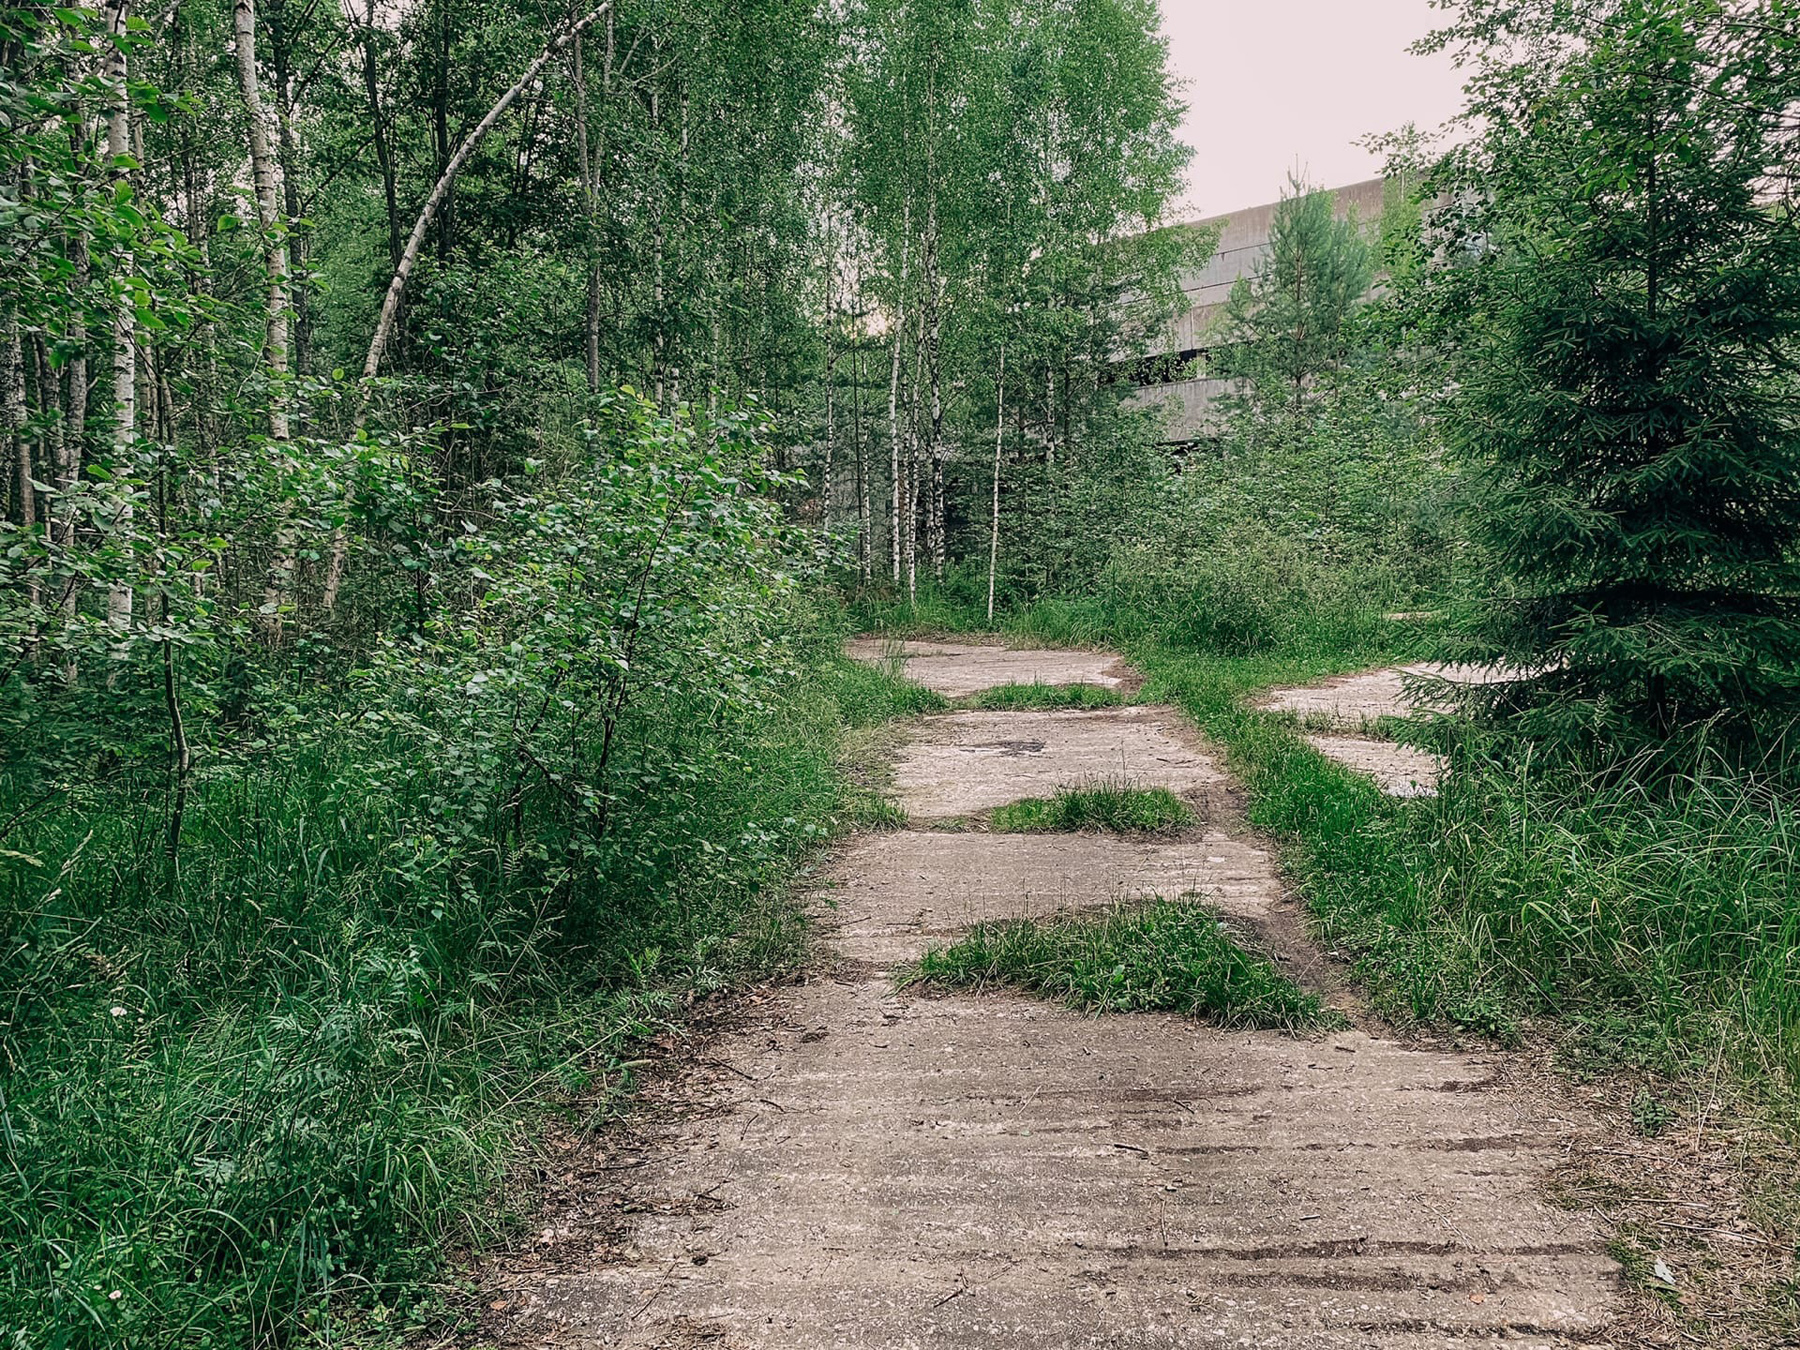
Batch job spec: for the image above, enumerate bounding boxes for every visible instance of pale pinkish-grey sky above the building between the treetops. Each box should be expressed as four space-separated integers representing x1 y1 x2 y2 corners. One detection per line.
1163 0 1462 218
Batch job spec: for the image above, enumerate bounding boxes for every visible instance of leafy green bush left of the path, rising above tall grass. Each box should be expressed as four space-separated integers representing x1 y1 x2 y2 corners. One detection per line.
343 394 810 921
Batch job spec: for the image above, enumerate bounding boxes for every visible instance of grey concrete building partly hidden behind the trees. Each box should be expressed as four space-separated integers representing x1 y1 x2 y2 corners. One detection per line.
1138 178 1386 445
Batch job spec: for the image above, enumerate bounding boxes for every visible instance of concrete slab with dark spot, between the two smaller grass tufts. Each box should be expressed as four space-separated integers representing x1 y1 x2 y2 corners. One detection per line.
895 707 1226 821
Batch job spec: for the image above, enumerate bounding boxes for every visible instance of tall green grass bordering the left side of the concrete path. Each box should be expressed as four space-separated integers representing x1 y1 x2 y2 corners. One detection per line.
0 644 916 1348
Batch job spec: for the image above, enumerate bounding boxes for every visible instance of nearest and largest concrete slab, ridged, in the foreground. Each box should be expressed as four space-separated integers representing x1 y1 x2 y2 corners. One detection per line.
482 979 1616 1350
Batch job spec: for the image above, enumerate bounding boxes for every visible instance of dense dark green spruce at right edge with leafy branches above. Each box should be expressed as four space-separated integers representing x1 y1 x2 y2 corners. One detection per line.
1431 0 1800 738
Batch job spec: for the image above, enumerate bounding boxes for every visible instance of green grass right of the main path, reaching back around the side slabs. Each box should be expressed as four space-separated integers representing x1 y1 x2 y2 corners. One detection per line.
853 601 1800 1103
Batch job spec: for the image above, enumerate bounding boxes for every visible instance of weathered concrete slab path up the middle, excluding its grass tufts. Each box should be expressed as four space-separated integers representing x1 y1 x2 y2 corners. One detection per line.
482 648 1616 1350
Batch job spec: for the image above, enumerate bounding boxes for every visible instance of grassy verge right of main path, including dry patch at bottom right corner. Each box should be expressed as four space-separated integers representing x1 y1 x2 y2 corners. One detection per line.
853 586 1800 1348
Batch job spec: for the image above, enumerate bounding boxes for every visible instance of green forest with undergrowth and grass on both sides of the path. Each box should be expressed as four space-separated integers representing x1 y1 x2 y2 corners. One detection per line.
0 0 1800 1350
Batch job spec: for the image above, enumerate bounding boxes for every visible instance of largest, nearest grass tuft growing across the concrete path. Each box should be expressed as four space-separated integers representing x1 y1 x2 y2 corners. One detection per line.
904 900 1339 1031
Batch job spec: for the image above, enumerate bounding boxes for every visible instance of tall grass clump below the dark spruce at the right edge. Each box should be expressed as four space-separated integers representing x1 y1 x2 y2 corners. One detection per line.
1314 752 1800 1076
